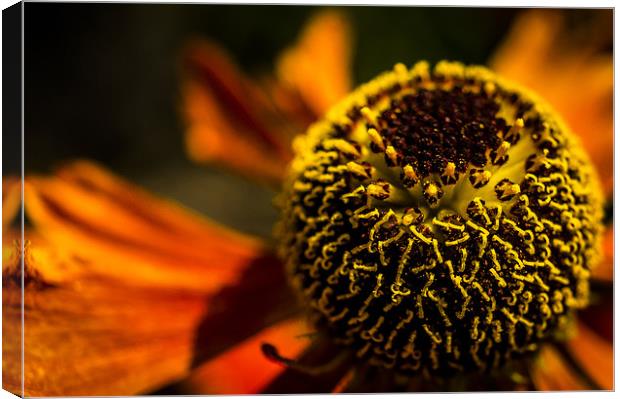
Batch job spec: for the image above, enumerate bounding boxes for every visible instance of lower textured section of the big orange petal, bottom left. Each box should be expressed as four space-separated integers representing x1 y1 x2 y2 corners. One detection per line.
3 232 291 396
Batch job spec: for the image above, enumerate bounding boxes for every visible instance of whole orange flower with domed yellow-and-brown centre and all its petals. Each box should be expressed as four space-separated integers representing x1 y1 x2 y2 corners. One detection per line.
3 7 613 395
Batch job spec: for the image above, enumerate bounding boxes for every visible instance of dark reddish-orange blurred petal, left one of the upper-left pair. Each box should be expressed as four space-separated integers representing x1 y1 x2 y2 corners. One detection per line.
183 41 291 181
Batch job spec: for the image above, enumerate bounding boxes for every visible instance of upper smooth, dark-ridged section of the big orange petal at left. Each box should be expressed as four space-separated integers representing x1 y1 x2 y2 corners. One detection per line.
25 161 265 292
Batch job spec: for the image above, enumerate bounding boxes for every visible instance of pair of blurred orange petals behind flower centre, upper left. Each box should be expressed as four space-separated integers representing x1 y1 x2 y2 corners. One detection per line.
183 10 351 184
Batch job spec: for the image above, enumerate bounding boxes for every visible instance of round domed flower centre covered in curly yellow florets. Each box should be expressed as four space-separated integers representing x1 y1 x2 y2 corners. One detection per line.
278 62 601 375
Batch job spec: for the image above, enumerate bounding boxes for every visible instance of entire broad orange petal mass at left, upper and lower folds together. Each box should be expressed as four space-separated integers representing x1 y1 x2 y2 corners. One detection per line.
3 162 290 396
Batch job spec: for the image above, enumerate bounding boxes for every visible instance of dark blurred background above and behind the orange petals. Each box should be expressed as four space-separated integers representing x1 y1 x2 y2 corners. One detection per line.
18 3 611 236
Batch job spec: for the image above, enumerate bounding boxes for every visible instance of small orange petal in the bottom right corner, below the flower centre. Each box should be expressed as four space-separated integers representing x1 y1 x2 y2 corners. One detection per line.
568 322 614 390
